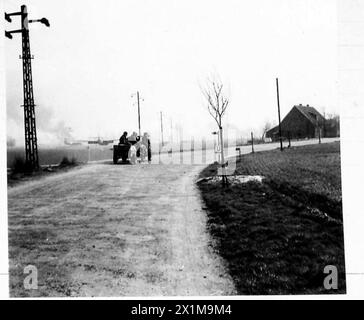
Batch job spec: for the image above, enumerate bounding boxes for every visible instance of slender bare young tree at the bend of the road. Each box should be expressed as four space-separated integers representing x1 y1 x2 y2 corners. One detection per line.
202 79 229 185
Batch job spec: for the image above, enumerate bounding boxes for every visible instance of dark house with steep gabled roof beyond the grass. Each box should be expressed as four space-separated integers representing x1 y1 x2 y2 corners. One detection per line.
266 104 327 141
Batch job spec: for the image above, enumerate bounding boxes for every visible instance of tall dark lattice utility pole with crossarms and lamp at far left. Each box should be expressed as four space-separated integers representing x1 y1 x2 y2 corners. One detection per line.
5 5 49 170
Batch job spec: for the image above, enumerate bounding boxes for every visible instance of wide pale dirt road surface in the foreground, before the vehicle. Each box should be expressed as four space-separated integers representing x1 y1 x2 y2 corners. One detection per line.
9 163 235 296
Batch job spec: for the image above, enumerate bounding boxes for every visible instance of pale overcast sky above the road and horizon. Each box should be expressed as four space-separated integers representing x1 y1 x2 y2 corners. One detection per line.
4 0 339 144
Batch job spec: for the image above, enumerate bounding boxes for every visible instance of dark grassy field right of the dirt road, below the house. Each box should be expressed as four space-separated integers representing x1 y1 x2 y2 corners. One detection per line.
198 142 346 294
